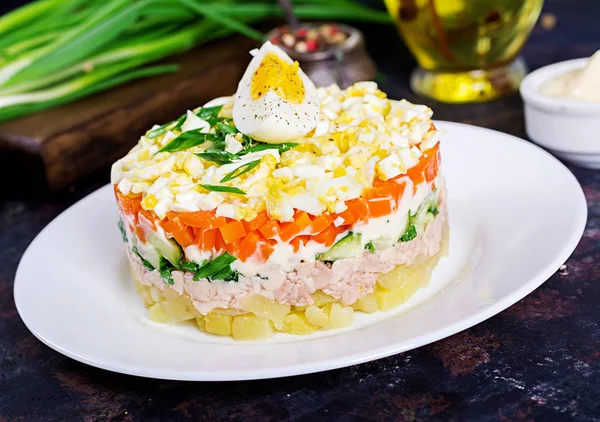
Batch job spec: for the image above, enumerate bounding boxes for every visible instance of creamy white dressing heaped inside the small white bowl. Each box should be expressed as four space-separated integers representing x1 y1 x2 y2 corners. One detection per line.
541 50 600 101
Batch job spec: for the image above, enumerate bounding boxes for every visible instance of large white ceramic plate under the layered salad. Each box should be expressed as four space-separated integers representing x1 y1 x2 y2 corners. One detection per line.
14 122 587 381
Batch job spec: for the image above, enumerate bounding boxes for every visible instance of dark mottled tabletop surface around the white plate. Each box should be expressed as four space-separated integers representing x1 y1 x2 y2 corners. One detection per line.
0 0 600 422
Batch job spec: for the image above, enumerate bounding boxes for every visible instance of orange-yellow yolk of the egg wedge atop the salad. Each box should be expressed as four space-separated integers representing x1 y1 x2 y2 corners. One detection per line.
250 52 304 104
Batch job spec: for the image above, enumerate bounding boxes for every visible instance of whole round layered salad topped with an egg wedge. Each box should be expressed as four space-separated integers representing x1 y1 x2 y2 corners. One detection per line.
111 43 447 340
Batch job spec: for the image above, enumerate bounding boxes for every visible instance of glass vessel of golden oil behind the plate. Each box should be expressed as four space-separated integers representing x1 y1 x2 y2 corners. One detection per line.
385 0 543 103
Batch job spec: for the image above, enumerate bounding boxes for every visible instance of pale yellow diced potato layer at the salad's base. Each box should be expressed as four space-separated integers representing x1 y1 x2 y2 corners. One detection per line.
136 224 448 340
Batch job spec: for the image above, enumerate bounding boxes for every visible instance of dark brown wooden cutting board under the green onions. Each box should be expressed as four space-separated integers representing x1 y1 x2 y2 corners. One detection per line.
0 37 253 190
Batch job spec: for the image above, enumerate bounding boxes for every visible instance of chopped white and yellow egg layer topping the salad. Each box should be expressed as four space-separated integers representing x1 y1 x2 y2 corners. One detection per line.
111 82 440 221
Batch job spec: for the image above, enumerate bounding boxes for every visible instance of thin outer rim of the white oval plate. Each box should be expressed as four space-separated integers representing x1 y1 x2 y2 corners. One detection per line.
13 120 588 382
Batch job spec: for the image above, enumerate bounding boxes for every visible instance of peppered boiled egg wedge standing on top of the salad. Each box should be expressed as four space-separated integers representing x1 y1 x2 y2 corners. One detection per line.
233 42 320 144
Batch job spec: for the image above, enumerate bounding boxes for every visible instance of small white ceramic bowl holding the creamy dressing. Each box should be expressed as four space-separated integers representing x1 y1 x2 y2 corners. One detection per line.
521 59 600 169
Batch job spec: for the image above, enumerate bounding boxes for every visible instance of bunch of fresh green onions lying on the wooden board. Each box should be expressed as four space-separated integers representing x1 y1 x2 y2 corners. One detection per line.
0 0 390 122
